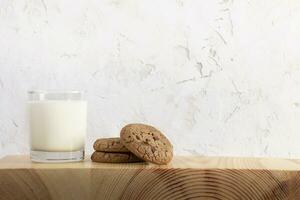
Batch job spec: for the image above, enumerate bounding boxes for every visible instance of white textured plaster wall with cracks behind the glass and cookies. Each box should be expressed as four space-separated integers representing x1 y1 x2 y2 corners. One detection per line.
0 0 300 158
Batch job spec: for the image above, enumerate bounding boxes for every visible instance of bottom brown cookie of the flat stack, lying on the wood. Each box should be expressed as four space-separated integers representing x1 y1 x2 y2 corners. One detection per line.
91 151 143 163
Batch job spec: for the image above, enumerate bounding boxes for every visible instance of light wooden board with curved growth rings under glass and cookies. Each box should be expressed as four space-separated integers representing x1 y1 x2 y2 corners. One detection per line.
0 156 300 200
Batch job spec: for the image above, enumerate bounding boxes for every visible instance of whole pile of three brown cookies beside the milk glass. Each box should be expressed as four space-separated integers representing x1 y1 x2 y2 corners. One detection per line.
91 124 173 164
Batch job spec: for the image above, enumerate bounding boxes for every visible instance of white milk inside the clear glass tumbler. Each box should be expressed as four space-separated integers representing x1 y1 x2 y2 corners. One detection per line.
28 100 87 152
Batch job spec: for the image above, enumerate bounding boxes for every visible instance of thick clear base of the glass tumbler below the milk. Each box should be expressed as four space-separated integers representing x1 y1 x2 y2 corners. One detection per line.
30 150 84 163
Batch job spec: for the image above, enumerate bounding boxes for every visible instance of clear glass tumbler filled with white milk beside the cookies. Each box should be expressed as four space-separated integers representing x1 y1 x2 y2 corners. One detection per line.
28 91 87 162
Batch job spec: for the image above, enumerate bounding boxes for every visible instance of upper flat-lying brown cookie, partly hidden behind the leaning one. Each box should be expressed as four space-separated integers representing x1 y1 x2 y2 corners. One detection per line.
93 138 130 152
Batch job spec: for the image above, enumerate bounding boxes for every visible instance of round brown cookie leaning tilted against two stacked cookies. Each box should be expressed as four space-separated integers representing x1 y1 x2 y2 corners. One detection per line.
120 124 173 164
